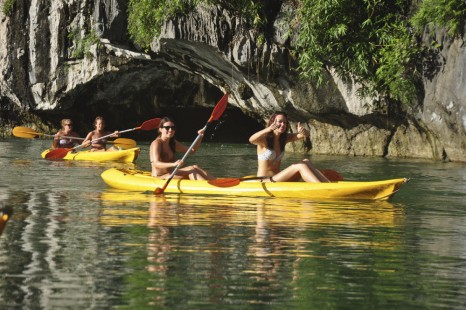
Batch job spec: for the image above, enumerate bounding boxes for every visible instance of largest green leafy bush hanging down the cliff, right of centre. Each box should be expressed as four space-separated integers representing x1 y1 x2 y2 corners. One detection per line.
297 0 422 107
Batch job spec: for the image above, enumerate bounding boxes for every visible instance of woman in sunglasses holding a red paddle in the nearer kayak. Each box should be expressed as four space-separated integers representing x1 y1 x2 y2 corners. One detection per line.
149 117 214 180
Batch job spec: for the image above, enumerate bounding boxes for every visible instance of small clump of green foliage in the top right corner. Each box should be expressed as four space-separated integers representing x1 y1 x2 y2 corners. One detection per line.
411 0 466 37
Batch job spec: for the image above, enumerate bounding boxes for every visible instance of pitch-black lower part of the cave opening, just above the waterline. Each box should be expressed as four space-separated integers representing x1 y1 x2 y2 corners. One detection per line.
39 105 263 143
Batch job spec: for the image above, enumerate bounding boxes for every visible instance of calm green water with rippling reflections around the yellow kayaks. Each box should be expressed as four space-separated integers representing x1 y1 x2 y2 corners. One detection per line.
0 139 466 309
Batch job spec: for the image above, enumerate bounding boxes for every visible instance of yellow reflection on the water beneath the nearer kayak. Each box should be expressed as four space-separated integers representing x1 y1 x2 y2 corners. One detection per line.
100 189 403 229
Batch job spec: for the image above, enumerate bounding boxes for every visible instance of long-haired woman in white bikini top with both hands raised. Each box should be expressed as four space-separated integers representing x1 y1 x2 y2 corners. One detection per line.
249 112 330 182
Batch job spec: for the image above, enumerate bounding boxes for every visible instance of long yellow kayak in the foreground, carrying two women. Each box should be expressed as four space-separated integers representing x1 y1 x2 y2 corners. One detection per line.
101 168 408 200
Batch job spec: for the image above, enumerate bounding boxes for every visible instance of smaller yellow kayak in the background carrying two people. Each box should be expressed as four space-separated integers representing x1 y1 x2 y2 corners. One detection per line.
41 147 141 163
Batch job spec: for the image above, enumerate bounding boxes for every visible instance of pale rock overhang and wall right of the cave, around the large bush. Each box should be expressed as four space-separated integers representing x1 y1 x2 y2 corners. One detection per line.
153 5 466 161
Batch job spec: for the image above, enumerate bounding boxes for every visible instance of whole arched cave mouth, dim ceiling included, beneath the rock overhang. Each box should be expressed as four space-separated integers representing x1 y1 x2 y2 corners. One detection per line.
43 66 263 143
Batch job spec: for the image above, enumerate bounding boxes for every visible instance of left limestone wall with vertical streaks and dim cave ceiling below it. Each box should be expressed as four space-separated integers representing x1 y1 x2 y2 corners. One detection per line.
0 0 226 135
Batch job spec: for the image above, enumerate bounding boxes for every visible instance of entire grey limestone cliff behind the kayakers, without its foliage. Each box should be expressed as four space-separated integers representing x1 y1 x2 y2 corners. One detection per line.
0 0 466 161
